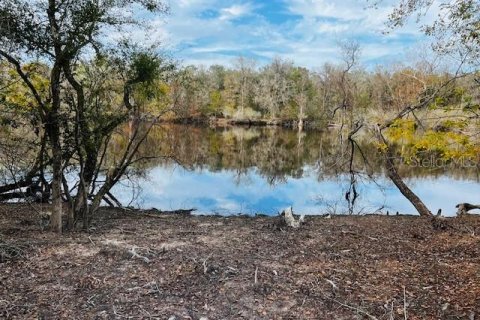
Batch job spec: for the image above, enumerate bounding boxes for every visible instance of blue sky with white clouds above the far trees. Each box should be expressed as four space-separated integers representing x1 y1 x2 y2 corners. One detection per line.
144 0 437 68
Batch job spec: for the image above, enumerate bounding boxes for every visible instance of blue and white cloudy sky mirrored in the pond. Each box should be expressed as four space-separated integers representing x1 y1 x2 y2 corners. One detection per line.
115 165 480 216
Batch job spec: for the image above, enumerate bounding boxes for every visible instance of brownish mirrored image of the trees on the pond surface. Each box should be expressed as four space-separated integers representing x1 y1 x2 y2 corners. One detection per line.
116 124 479 185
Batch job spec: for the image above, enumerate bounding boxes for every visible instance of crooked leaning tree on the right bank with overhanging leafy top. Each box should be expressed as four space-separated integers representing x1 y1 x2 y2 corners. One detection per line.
364 0 480 216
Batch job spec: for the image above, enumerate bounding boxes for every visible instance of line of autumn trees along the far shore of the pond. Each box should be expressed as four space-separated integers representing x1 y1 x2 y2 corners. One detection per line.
166 52 478 127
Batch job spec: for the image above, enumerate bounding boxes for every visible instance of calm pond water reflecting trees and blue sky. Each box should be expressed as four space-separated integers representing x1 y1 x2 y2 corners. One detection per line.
115 125 480 215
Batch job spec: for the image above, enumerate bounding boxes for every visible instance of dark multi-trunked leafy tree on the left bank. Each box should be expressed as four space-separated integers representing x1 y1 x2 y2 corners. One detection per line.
0 0 166 232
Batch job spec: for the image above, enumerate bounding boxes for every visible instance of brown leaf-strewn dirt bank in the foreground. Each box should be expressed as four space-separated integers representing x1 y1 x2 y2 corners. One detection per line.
0 205 480 320
